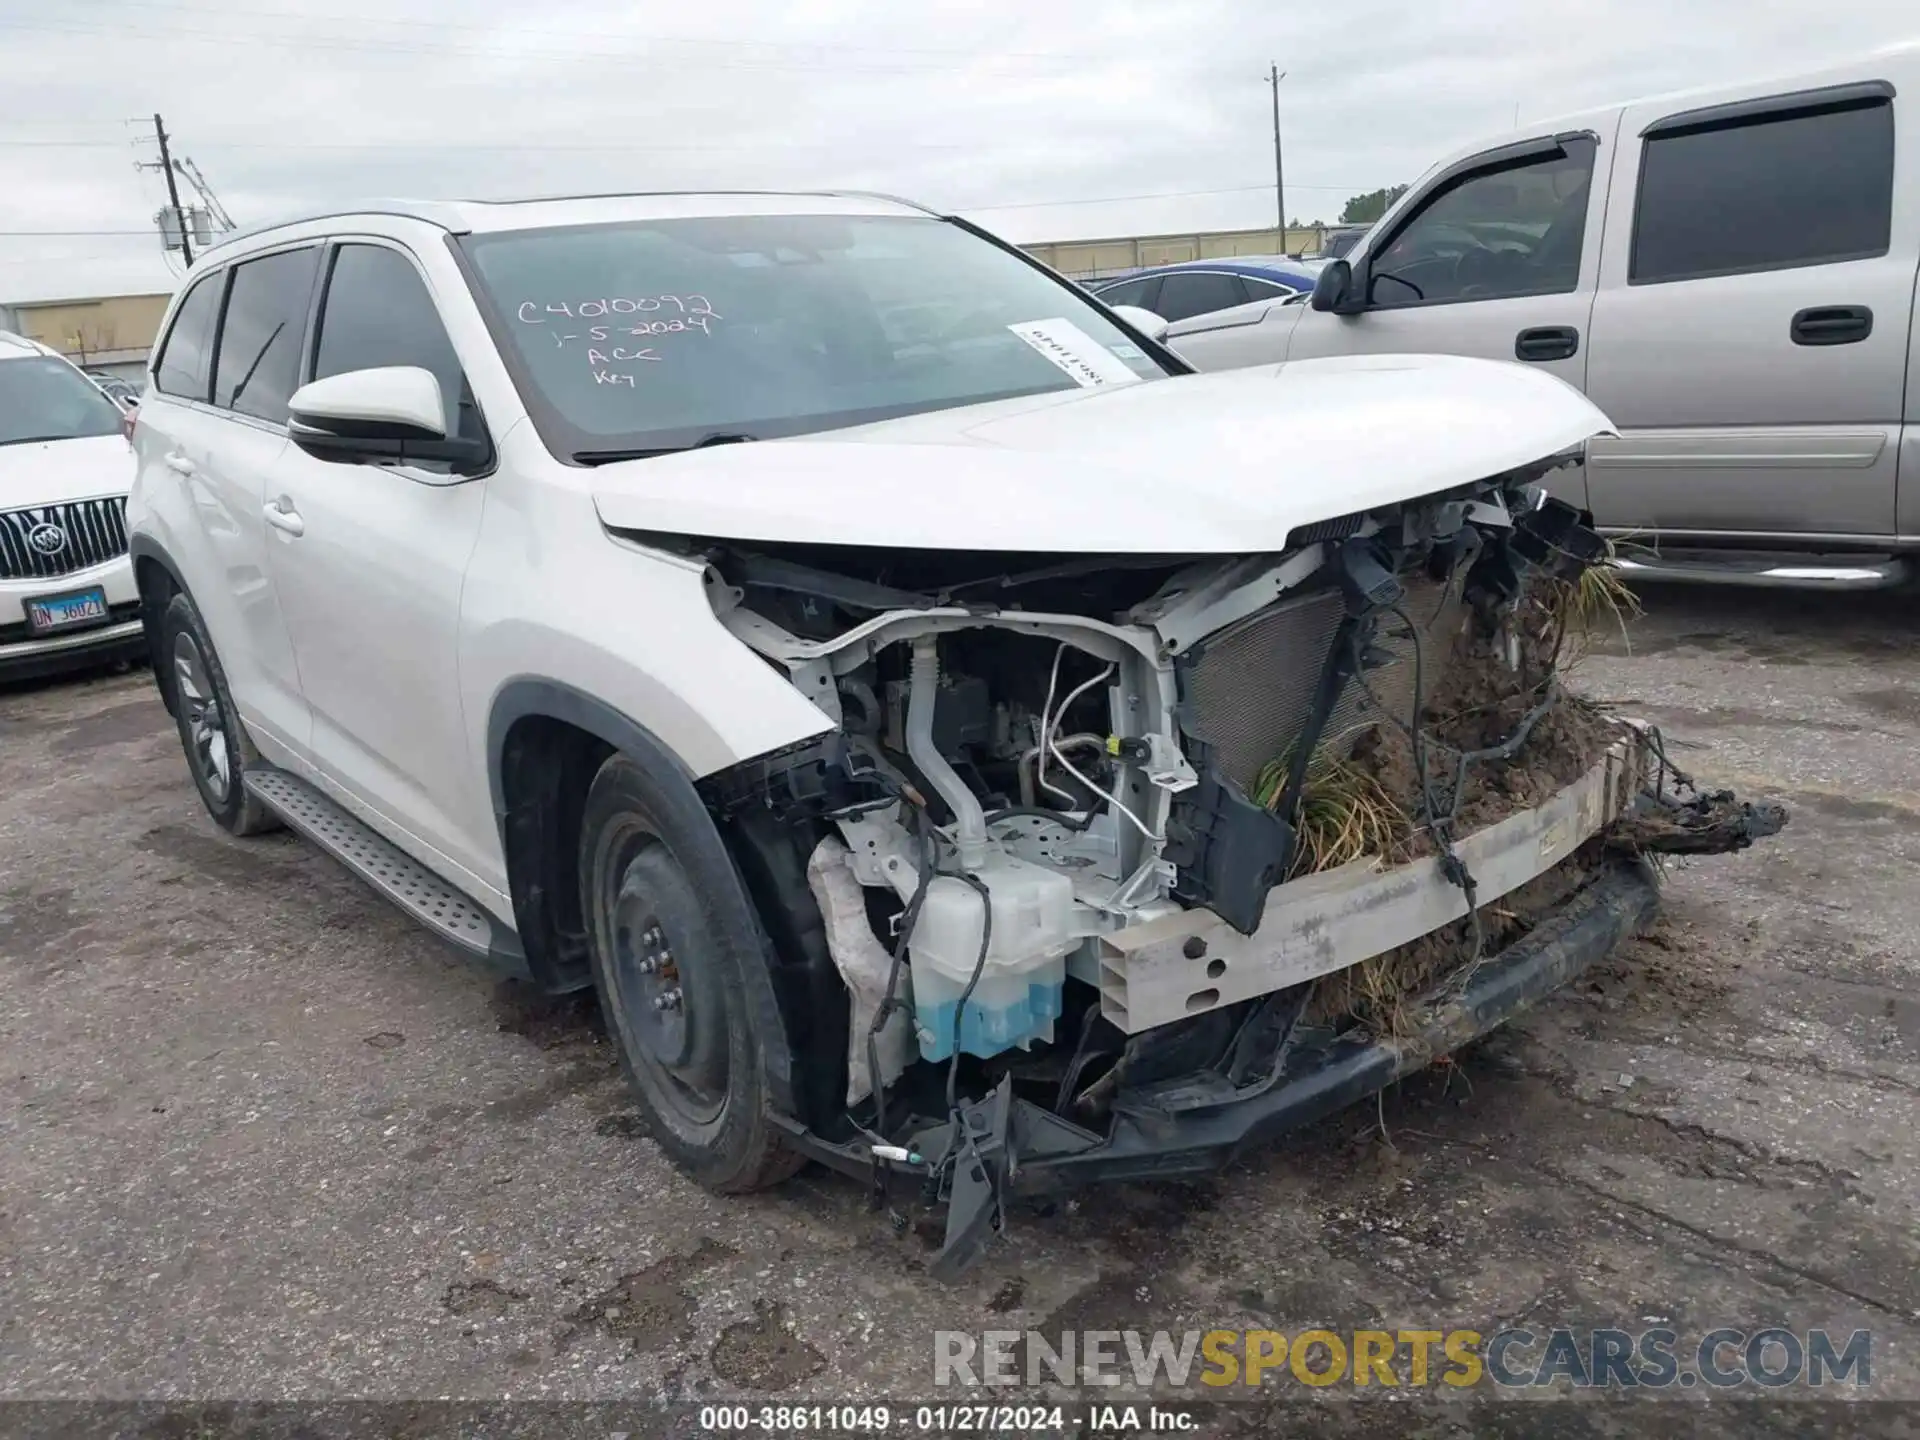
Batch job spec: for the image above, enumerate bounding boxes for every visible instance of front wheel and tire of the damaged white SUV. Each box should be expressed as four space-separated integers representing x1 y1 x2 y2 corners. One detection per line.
580 755 804 1194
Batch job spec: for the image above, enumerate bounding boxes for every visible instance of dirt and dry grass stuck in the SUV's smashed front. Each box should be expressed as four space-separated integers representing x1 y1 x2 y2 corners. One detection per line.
1260 568 1638 1035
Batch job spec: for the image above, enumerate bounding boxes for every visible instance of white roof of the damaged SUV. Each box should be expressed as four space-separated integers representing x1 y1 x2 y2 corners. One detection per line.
202 190 939 255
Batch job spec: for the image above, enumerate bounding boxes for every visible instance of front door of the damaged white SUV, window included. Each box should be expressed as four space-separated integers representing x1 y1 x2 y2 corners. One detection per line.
267 240 497 897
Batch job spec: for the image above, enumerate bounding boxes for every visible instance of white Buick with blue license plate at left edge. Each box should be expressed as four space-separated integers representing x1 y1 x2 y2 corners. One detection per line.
0 330 146 680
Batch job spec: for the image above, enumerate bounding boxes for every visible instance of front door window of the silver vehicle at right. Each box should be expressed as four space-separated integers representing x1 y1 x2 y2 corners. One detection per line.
1367 138 1594 309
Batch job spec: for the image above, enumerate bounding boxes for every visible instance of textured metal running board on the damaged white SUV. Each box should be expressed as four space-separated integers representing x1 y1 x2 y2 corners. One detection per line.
242 766 526 972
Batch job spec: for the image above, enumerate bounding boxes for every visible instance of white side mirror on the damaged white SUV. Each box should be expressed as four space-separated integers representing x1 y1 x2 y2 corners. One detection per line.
286 365 488 465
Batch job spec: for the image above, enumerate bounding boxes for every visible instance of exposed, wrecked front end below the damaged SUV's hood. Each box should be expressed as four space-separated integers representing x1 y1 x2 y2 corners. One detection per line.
675 457 1784 1271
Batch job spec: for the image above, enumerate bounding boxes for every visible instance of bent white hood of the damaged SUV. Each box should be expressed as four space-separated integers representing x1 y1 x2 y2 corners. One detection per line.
591 355 1611 555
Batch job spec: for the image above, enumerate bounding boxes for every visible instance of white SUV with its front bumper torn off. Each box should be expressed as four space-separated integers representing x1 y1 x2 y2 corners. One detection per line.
131 194 1782 1273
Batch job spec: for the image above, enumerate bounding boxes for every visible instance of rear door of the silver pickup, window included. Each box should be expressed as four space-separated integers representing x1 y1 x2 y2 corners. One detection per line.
1588 73 1920 538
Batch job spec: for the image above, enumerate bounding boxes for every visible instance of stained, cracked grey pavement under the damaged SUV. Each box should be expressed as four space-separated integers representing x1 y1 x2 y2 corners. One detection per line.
0 589 1920 1400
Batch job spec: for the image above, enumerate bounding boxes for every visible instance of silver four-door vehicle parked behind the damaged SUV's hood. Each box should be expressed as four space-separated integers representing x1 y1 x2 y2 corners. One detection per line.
1167 46 1920 586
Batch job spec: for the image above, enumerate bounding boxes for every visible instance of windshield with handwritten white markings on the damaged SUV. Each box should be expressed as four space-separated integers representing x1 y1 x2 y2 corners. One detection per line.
461 215 1167 463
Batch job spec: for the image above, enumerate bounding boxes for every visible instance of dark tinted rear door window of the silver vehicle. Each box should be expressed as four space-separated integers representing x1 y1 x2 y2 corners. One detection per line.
1628 98 1893 284
